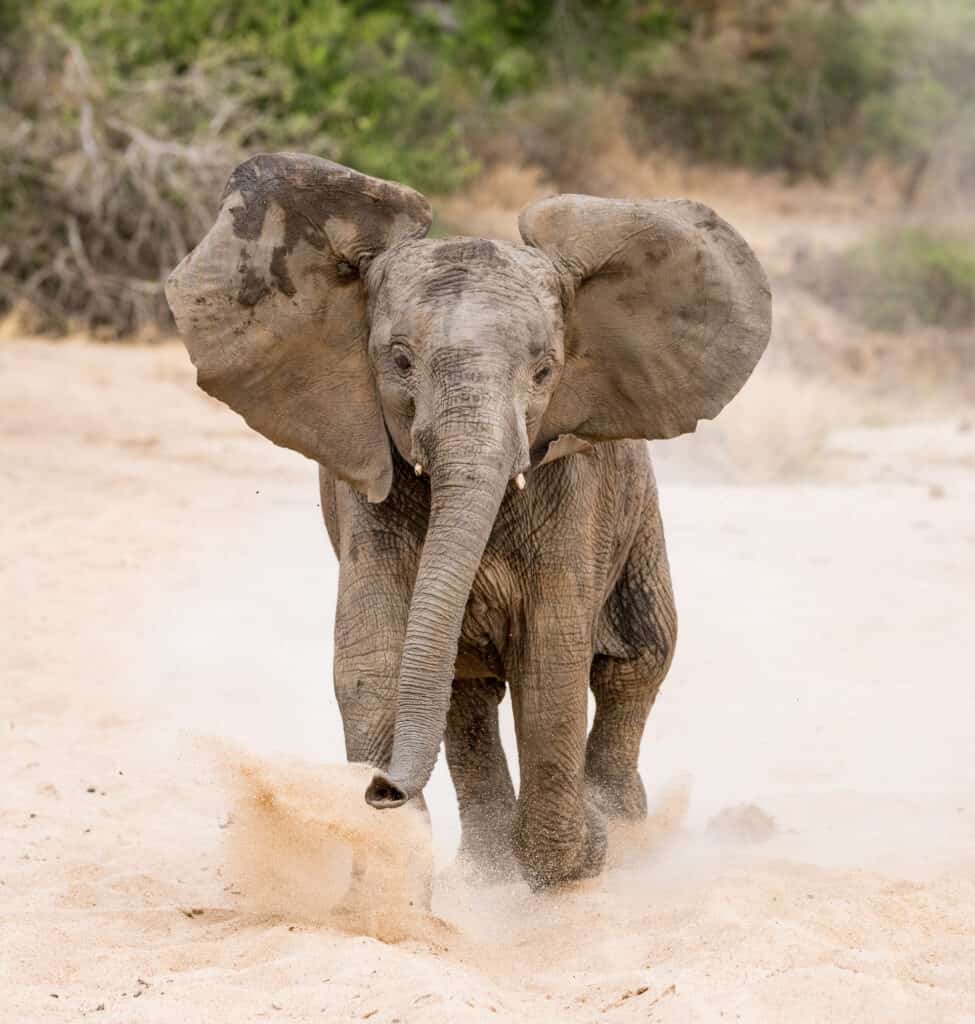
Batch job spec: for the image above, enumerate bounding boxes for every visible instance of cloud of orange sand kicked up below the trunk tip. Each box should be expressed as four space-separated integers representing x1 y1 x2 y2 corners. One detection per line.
208 742 437 942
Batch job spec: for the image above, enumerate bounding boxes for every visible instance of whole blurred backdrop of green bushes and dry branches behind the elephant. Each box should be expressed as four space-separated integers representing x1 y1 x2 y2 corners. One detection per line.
0 0 975 336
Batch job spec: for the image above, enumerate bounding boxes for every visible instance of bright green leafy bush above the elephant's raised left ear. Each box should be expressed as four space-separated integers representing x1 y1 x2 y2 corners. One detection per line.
44 0 477 191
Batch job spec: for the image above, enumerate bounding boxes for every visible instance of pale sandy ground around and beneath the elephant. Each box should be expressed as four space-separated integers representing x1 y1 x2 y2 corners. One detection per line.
0 341 975 1024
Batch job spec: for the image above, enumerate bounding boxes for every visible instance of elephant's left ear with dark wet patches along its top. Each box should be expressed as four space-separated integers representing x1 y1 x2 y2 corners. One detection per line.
166 153 430 501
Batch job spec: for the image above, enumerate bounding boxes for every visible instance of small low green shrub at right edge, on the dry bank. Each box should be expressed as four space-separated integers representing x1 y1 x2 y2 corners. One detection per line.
806 228 975 331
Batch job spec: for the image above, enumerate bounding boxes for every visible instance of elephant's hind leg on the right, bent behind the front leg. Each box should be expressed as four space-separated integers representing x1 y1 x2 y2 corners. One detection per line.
586 516 677 820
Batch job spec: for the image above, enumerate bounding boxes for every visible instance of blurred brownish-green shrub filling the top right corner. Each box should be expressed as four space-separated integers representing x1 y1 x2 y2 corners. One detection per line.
624 0 975 194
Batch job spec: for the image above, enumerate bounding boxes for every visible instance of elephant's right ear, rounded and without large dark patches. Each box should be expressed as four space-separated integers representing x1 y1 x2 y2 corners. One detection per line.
519 196 771 441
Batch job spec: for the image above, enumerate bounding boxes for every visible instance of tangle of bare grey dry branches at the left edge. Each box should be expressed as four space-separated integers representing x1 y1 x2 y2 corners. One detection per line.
0 32 241 335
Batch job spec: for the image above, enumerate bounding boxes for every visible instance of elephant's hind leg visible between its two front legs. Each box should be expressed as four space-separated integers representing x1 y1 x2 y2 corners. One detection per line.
444 679 516 882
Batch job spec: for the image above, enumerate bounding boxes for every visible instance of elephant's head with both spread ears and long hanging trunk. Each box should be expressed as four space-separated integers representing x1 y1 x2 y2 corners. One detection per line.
167 154 770 807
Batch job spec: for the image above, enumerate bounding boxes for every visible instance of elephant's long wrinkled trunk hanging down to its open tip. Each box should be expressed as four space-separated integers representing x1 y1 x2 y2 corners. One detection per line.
366 415 518 808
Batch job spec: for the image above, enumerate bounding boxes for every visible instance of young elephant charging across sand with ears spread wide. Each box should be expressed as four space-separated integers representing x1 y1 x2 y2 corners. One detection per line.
167 154 770 888
